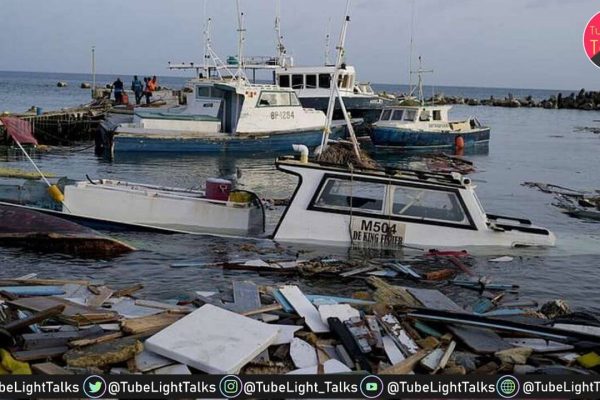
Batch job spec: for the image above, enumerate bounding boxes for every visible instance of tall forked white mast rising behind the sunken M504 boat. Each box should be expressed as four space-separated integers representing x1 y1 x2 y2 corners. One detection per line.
321 0 361 160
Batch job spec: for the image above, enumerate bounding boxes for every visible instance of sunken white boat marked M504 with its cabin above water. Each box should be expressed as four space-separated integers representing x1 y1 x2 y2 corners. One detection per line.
273 157 555 249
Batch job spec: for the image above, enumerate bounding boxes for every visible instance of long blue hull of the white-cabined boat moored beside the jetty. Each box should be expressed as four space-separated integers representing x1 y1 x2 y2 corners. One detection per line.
113 129 344 153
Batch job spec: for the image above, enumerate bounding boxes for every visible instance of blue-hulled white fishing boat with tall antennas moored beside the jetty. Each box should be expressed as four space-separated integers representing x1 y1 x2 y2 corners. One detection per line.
112 7 343 153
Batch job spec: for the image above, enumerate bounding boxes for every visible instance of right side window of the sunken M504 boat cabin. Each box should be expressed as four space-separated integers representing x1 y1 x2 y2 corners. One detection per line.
392 186 468 225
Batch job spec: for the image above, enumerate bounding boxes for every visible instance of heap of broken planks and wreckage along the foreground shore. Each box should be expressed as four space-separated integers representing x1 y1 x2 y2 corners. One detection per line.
0 252 600 374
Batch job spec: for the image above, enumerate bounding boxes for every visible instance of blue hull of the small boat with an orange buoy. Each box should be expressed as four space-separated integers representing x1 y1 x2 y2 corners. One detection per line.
371 127 490 149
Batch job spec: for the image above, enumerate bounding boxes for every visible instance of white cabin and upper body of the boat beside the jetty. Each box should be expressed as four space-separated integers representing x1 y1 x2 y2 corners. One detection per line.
119 80 325 135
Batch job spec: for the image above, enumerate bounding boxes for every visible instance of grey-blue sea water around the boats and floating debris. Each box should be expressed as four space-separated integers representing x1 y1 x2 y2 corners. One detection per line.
0 72 600 310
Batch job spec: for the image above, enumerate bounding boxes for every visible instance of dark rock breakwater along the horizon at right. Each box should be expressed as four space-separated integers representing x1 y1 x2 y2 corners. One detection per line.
383 89 600 111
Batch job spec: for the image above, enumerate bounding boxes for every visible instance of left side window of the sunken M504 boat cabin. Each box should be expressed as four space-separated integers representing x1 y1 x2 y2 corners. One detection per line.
314 178 385 214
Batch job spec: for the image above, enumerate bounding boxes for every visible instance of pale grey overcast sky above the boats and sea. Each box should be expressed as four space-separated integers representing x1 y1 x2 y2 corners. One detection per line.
0 0 600 89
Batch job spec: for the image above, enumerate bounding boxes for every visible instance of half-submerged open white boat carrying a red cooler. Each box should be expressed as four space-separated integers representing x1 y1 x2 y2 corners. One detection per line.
0 178 265 236
